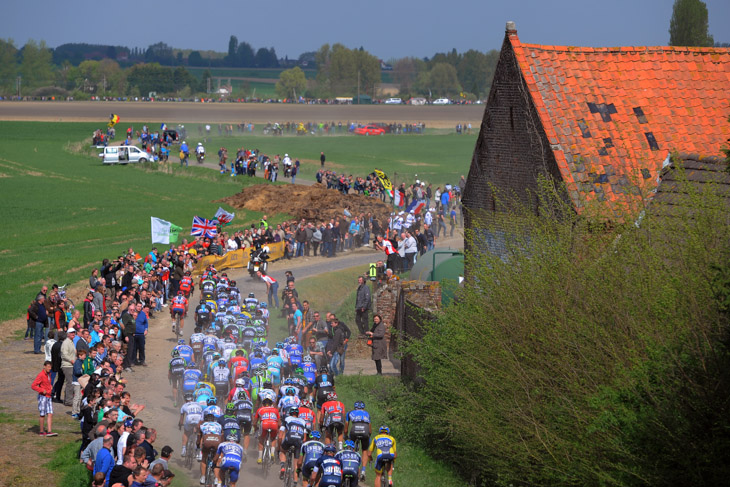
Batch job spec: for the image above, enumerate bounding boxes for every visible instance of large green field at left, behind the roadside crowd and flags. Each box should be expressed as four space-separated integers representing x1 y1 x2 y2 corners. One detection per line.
0 122 261 321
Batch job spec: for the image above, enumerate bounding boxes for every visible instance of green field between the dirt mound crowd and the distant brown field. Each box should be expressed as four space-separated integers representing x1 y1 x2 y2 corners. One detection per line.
180 124 477 190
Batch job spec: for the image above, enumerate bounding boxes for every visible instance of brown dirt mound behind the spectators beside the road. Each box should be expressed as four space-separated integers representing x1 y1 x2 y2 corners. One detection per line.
219 184 392 223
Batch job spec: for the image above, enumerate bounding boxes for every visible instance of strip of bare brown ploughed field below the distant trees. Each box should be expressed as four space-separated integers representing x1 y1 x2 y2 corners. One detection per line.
0 101 484 128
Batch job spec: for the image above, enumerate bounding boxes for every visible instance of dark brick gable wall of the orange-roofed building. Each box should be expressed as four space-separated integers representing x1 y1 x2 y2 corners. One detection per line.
463 29 561 255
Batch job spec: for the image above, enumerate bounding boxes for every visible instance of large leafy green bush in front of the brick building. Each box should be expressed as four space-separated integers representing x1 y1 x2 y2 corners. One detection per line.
407 170 730 485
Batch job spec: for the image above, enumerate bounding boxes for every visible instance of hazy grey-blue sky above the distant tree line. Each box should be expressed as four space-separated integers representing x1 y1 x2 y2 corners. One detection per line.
0 0 730 60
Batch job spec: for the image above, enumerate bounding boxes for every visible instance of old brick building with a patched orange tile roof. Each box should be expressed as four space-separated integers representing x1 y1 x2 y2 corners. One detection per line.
463 22 730 252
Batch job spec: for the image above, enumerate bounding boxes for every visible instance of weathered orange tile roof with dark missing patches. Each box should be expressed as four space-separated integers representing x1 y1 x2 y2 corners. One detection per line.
507 31 730 218
